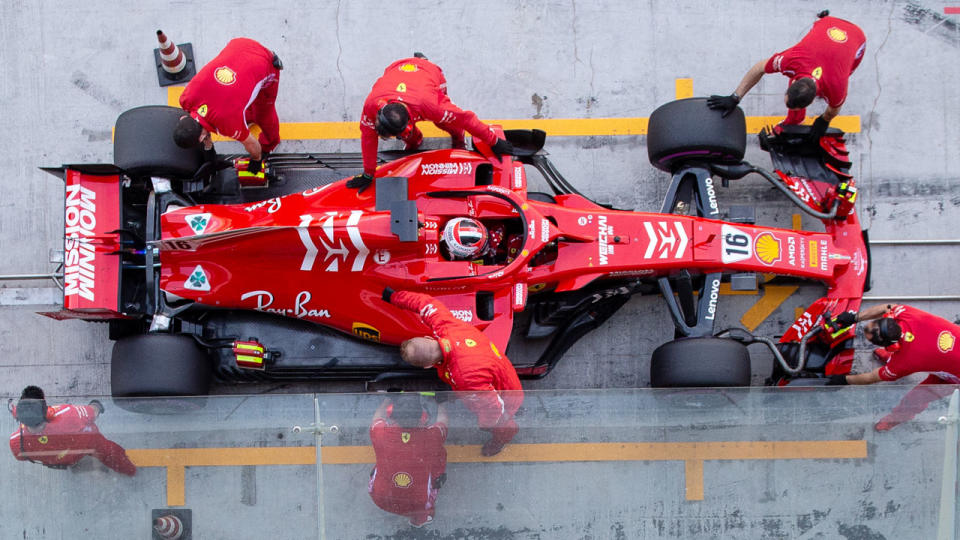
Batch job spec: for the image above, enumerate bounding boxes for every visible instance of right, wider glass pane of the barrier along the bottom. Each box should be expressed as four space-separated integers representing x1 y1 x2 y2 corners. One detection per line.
320 385 951 539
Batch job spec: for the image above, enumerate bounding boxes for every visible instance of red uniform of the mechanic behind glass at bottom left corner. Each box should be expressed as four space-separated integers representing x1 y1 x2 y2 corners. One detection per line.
10 405 137 476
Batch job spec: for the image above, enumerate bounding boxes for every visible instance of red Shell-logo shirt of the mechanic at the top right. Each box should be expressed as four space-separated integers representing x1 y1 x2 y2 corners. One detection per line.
764 17 867 124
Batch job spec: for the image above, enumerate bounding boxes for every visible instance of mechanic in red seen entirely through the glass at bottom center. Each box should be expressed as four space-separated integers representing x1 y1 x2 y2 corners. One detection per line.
367 393 448 527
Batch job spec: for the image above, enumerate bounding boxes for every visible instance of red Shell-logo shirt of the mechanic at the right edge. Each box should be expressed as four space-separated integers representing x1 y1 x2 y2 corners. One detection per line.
879 305 960 384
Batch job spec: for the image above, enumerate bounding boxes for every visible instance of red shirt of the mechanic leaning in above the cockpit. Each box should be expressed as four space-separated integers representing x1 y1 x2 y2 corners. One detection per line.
360 58 497 175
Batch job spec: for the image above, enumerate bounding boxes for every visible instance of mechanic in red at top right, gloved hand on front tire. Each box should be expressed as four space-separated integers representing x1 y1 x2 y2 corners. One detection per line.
707 11 867 138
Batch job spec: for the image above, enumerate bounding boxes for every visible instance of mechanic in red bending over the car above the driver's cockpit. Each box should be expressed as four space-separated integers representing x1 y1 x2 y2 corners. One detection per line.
348 53 513 189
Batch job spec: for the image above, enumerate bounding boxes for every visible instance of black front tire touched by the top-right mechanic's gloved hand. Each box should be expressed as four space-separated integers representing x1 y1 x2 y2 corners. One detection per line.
647 98 747 172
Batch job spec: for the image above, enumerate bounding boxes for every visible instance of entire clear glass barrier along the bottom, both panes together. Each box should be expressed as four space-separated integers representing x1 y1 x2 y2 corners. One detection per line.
0 385 952 539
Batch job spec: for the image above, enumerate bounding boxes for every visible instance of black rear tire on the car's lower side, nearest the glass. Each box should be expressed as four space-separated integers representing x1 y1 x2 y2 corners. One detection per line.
110 334 213 413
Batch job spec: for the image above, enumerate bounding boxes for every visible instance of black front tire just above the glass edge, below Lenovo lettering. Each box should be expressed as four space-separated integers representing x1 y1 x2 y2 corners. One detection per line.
650 337 750 388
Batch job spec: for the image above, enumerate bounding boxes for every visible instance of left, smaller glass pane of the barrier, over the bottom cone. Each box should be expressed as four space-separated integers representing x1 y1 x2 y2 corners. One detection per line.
0 395 318 539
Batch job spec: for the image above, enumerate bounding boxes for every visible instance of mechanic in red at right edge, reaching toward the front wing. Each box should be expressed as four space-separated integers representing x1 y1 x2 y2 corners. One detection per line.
830 304 960 431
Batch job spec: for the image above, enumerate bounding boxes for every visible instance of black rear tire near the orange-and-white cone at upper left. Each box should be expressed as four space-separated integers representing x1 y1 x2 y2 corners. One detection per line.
113 105 203 179
